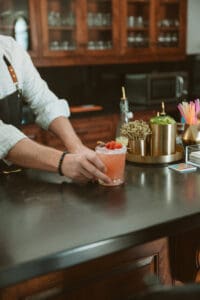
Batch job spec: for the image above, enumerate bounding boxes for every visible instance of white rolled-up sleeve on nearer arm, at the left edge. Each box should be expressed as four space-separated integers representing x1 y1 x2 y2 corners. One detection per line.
0 121 27 159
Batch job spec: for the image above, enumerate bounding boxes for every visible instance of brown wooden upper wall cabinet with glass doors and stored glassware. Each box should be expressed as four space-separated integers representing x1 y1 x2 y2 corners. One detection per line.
0 0 187 66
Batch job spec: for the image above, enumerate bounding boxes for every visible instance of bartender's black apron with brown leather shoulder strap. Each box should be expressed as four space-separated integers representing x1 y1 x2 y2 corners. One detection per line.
0 55 23 174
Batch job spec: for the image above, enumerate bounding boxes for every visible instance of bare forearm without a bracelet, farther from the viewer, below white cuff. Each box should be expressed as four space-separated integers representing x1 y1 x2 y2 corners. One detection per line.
49 117 83 153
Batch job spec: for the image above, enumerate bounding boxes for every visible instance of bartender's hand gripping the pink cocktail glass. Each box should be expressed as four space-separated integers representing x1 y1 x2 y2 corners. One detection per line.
62 146 111 184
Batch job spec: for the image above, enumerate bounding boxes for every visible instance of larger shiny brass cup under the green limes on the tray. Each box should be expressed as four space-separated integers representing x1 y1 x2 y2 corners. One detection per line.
150 123 177 156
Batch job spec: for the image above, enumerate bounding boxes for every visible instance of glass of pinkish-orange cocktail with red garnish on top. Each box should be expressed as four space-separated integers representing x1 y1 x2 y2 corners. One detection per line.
95 146 127 186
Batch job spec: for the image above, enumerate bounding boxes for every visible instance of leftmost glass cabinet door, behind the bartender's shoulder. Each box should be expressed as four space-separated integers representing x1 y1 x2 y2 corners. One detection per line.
0 0 37 56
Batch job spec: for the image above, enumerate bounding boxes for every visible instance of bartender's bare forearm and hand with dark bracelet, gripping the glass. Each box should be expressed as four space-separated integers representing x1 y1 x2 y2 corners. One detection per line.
6 138 110 183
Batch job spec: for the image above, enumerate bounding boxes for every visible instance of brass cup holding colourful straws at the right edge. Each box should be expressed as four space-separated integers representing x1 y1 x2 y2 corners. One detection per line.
182 124 200 146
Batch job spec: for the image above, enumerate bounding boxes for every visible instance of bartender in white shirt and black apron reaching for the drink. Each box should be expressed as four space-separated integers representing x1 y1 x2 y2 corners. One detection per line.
0 35 110 183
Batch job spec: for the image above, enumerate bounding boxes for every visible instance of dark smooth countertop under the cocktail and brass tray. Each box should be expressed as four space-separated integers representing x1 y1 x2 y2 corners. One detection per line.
0 163 200 287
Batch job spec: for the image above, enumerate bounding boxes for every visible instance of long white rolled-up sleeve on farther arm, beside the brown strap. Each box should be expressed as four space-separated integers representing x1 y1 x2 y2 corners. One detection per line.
12 42 70 130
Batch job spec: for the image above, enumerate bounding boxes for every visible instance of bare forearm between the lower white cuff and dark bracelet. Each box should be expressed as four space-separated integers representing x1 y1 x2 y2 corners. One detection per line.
6 138 62 172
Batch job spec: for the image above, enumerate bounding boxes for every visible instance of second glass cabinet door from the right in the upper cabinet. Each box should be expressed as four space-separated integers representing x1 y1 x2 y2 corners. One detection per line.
121 0 152 53
